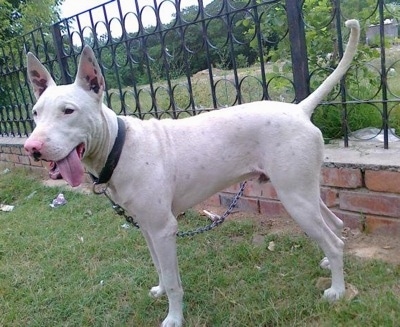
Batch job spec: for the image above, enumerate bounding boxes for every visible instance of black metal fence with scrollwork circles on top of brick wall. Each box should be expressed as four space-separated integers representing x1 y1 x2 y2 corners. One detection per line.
0 0 400 148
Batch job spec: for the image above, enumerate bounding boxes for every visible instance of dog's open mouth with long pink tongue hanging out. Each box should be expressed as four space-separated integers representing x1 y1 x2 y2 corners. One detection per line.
49 143 85 186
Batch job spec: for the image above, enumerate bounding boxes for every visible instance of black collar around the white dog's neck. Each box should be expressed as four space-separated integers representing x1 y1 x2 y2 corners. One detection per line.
89 117 125 184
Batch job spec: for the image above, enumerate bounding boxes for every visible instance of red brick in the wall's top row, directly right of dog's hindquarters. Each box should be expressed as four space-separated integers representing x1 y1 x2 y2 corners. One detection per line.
321 167 362 188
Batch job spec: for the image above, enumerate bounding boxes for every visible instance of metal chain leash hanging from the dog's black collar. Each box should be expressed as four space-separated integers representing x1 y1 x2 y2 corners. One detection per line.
93 181 247 237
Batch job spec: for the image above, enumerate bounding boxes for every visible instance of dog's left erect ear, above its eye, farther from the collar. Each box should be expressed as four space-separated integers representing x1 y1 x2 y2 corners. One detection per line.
27 52 56 100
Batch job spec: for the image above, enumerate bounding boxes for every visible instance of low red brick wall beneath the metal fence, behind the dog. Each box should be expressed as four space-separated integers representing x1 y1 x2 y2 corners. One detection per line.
0 138 400 236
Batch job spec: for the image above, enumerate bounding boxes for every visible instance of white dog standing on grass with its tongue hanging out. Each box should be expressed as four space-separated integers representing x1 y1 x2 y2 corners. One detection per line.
25 20 360 327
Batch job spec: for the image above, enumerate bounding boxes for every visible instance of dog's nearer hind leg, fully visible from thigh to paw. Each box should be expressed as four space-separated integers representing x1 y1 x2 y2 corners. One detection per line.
271 183 345 301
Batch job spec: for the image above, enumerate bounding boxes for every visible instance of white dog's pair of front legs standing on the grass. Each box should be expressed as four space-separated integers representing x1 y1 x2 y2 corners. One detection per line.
143 214 183 327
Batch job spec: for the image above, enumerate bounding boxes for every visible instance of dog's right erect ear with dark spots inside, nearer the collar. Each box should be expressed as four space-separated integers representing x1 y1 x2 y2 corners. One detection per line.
75 45 105 96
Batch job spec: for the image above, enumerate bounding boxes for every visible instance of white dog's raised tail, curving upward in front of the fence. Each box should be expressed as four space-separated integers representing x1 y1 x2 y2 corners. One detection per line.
298 19 360 117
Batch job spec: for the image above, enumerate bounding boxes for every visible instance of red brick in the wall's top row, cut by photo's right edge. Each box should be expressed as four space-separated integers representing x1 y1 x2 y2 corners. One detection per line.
365 170 400 193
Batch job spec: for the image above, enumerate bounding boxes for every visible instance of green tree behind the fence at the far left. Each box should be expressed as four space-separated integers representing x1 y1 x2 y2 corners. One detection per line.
0 0 63 135
